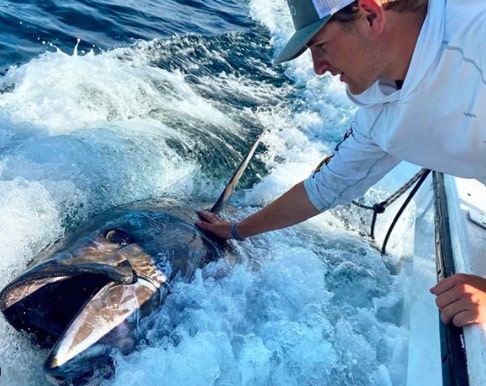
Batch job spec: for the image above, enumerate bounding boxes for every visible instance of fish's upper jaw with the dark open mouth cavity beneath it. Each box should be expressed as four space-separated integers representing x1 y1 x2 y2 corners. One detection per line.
0 250 136 348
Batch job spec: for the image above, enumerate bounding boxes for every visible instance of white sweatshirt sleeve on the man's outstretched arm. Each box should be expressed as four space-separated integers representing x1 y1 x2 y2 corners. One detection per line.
304 123 400 212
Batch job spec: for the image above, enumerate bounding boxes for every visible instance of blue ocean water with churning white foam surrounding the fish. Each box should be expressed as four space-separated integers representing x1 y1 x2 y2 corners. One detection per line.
0 0 440 386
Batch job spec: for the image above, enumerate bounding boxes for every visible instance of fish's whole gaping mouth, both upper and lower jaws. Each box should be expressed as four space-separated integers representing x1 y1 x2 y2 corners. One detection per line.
0 244 166 384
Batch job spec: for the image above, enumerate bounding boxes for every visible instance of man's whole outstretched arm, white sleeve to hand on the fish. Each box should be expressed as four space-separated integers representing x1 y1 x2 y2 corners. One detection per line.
196 124 399 239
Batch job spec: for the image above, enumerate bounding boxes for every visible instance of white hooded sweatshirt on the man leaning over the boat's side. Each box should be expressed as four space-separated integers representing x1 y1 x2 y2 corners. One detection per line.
304 0 486 211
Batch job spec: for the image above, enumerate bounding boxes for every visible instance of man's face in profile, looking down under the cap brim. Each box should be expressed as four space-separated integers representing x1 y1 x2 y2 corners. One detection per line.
308 18 384 94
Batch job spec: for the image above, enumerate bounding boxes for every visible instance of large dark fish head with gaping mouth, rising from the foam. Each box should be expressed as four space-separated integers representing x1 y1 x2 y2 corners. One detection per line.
0 200 225 384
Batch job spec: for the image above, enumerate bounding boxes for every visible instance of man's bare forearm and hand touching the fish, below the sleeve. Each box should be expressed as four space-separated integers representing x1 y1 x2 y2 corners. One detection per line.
196 182 319 239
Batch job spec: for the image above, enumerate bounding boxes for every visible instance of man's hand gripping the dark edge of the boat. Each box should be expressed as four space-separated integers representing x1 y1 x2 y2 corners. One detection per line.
430 273 486 327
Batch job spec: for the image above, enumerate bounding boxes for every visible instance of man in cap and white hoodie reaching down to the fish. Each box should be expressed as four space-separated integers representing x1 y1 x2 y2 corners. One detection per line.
197 0 486 326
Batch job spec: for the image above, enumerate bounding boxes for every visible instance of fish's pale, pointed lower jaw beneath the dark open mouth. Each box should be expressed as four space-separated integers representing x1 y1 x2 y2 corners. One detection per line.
44 279 166 380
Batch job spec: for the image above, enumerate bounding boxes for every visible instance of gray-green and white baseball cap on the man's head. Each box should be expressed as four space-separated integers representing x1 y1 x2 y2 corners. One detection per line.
273 0 355 64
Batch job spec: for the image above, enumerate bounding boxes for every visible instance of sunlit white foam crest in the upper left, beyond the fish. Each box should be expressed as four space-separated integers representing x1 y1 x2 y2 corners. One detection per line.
0 45 239 135
